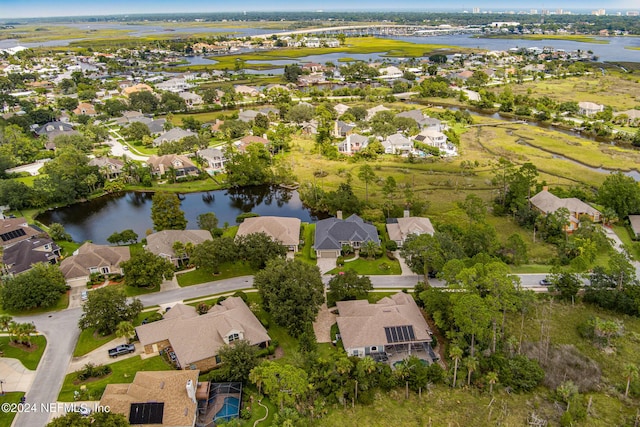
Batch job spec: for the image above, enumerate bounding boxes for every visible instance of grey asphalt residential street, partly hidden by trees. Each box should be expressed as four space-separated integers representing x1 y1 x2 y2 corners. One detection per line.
13 274 545 426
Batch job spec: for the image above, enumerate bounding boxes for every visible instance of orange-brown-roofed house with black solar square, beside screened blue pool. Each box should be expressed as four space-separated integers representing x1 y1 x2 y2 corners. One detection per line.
100 370 200 427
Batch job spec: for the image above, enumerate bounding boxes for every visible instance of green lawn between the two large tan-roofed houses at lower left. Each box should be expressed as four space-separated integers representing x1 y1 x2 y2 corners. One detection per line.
58 356 171 402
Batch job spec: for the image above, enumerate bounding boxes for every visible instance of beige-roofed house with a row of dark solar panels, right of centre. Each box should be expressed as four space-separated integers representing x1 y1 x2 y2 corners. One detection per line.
336 292 435 360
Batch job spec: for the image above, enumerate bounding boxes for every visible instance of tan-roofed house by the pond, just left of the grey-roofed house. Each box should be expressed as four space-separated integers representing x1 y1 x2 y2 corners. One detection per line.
236 216 300 252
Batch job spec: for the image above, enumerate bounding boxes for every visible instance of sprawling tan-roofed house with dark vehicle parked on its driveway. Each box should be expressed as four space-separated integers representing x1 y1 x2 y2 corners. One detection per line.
136 297 271 371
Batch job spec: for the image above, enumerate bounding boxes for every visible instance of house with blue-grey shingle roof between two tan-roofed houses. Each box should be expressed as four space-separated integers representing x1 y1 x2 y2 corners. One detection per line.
313 211 380 258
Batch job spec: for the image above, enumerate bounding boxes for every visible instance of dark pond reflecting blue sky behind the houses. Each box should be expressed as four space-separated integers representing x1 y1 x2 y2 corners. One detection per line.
37 186 326 244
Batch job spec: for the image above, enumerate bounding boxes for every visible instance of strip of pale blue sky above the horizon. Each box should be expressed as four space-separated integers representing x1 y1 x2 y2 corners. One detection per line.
0 0 640 19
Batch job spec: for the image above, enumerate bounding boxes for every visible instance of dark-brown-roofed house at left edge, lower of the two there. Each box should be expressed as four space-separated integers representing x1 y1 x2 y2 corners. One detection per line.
2 236 61 275
